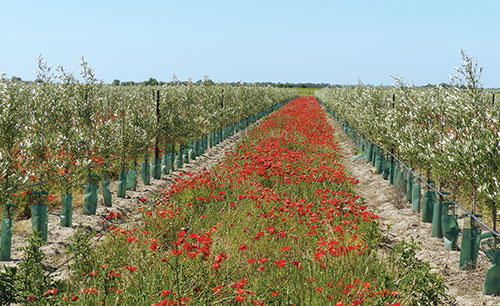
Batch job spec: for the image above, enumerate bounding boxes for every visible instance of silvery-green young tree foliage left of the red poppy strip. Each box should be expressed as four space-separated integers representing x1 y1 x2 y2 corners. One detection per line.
0 58 294 222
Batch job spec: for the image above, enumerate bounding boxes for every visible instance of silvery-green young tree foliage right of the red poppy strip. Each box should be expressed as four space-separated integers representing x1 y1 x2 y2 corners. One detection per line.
316 51 500 229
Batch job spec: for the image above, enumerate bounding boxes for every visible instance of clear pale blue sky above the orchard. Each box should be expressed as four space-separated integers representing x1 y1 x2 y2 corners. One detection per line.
0 0 500 87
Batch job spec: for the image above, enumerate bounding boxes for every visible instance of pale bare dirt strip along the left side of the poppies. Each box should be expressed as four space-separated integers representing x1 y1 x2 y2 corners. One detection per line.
0 123 252 280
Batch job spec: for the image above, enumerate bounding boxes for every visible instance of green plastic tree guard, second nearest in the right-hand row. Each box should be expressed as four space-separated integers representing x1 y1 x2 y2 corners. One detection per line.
460 215 481 270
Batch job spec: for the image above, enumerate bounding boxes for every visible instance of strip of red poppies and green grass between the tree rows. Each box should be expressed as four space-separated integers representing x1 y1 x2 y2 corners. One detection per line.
5 97 452 305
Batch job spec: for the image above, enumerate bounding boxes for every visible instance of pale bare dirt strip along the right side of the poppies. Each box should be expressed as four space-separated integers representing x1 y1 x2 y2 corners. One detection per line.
330 119 500 306
